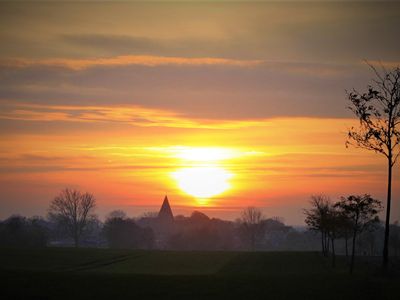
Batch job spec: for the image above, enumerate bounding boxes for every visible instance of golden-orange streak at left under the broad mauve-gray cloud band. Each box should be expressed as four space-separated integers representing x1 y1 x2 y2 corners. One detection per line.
0 104 266 129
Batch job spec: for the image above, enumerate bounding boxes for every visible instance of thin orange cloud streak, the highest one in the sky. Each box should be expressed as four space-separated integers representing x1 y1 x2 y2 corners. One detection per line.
0 55 262 70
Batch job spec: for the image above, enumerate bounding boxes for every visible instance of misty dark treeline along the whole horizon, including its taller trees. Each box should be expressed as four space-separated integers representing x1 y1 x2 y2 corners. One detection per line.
0 189 400 256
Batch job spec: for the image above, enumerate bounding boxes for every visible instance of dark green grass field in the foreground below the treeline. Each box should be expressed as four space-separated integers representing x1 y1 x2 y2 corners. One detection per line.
0 248 400 300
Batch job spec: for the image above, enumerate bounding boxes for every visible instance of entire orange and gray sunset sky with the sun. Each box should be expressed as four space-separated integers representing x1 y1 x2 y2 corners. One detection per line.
0 1 400 225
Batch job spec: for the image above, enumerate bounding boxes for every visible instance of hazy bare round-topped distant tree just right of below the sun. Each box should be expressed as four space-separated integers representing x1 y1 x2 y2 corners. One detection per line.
239 207 264 250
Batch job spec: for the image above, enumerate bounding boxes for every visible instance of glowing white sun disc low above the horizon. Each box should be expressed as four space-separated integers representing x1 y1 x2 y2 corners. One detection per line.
172 167 232 198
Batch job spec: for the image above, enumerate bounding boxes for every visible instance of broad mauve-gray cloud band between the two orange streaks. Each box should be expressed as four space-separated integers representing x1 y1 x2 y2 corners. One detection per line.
0 62 372 119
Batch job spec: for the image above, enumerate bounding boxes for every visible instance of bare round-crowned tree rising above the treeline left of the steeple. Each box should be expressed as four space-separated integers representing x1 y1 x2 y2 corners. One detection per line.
48 189 96 247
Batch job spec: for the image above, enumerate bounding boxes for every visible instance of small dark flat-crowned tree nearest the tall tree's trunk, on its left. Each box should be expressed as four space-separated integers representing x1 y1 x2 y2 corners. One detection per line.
334 194 382 273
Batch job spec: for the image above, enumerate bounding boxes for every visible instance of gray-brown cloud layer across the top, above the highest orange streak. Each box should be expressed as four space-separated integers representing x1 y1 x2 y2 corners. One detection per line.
0 1 400 62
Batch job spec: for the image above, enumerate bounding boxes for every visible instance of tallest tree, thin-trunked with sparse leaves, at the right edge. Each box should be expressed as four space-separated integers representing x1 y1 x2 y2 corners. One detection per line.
346 66 400 270
